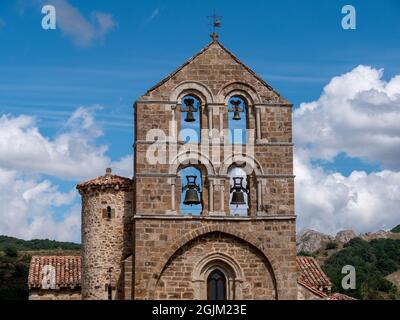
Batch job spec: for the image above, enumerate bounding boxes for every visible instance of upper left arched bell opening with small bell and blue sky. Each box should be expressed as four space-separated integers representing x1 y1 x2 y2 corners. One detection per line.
179 95 201 143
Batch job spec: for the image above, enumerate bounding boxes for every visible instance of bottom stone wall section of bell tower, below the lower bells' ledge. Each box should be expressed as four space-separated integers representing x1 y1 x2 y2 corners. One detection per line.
134 217 297 299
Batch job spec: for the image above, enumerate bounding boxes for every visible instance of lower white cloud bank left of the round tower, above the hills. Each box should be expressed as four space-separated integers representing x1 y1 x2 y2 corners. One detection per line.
0 168 81 241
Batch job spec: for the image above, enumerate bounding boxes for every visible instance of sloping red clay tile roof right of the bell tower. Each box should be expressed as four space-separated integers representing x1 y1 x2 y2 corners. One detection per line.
296 257 332 291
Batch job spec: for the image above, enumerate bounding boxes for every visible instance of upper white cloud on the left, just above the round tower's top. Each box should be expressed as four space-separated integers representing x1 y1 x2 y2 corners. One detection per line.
0 107 132 180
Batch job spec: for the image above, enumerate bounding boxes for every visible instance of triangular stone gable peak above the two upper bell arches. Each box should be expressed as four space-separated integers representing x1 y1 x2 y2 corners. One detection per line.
139 41 290 105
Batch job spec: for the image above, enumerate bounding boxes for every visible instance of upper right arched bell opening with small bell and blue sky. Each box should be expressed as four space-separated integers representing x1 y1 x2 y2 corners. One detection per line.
228 96 248 144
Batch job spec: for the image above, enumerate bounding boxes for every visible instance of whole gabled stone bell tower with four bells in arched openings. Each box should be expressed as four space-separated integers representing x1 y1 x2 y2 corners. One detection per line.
125 36 297 300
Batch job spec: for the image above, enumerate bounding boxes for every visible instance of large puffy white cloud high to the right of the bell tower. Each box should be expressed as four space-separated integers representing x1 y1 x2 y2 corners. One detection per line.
293 66 400 170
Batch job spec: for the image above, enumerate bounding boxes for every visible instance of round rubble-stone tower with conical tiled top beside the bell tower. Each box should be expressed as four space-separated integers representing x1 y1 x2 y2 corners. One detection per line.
77 169 133 300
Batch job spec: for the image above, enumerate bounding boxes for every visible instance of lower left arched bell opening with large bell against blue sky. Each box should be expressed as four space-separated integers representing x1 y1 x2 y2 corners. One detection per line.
180 166 203 215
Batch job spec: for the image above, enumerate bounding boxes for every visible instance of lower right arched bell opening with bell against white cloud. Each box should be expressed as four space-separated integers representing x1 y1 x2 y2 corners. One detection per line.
229 167 249 216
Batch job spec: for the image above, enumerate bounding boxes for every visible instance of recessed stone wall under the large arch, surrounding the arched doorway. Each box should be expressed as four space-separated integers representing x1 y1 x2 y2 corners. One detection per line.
155 233 276 300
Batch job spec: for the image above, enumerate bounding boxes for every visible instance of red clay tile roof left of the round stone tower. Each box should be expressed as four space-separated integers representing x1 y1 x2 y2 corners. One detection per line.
28 256 81 289
